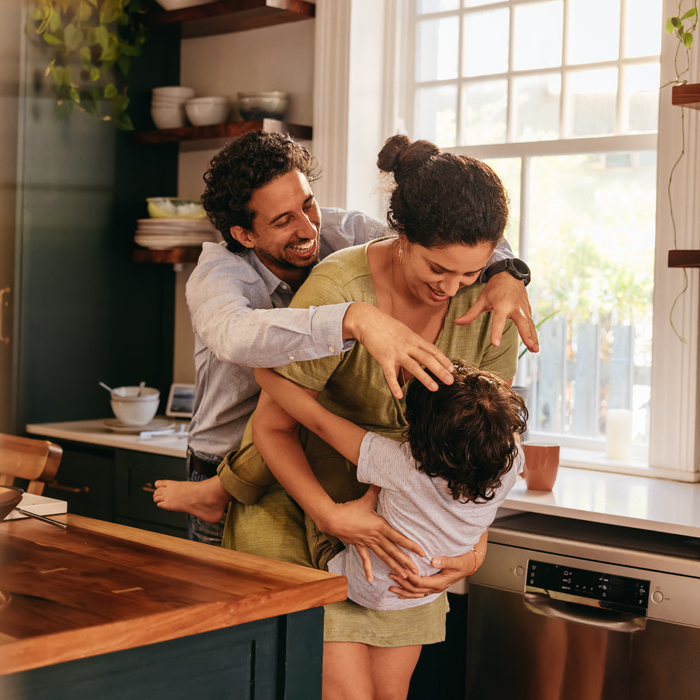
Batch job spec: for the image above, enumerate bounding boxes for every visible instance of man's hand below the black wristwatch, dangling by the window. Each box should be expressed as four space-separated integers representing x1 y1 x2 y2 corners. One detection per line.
455 272 540 352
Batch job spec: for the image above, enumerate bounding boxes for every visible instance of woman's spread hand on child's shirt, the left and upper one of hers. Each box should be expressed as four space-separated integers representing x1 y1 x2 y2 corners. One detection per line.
317 486 425 583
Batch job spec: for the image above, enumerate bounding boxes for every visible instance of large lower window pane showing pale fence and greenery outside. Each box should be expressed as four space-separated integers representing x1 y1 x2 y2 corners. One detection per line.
528 152 656 442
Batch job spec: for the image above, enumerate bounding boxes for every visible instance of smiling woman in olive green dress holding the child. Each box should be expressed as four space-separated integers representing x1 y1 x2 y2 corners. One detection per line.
215 136 517 698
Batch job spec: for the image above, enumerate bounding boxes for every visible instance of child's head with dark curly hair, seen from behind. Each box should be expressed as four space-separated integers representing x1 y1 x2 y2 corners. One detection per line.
405 360 527 502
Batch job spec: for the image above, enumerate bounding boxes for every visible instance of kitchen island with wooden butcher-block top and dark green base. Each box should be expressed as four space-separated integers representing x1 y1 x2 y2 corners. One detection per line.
0 515 347 700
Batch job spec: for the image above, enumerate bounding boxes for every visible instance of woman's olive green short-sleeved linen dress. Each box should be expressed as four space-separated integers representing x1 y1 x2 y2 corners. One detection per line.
219 242 518 646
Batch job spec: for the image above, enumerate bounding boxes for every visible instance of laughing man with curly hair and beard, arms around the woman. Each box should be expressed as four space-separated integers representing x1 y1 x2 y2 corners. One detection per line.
182 132 538 544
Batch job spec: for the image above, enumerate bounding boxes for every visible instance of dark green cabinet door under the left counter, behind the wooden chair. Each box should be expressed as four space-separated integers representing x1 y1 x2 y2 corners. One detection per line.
43 440 115 522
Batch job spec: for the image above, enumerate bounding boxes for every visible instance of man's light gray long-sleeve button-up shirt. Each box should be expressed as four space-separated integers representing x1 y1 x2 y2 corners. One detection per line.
186 209 513 461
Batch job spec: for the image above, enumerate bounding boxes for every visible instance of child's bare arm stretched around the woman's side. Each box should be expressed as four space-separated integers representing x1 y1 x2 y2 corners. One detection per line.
255 369 367 464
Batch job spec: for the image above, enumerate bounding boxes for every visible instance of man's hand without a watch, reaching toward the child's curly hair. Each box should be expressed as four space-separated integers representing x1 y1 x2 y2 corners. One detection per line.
343 302 454 399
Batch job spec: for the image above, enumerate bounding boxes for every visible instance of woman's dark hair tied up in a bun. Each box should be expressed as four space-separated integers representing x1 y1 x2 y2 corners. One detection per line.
377 135 508 248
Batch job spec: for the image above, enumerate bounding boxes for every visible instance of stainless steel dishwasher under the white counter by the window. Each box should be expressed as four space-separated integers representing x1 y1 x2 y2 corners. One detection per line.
466 513 700 700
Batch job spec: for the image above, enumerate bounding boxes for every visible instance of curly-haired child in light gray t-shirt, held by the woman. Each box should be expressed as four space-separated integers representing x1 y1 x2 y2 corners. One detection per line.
253 360 527 610
